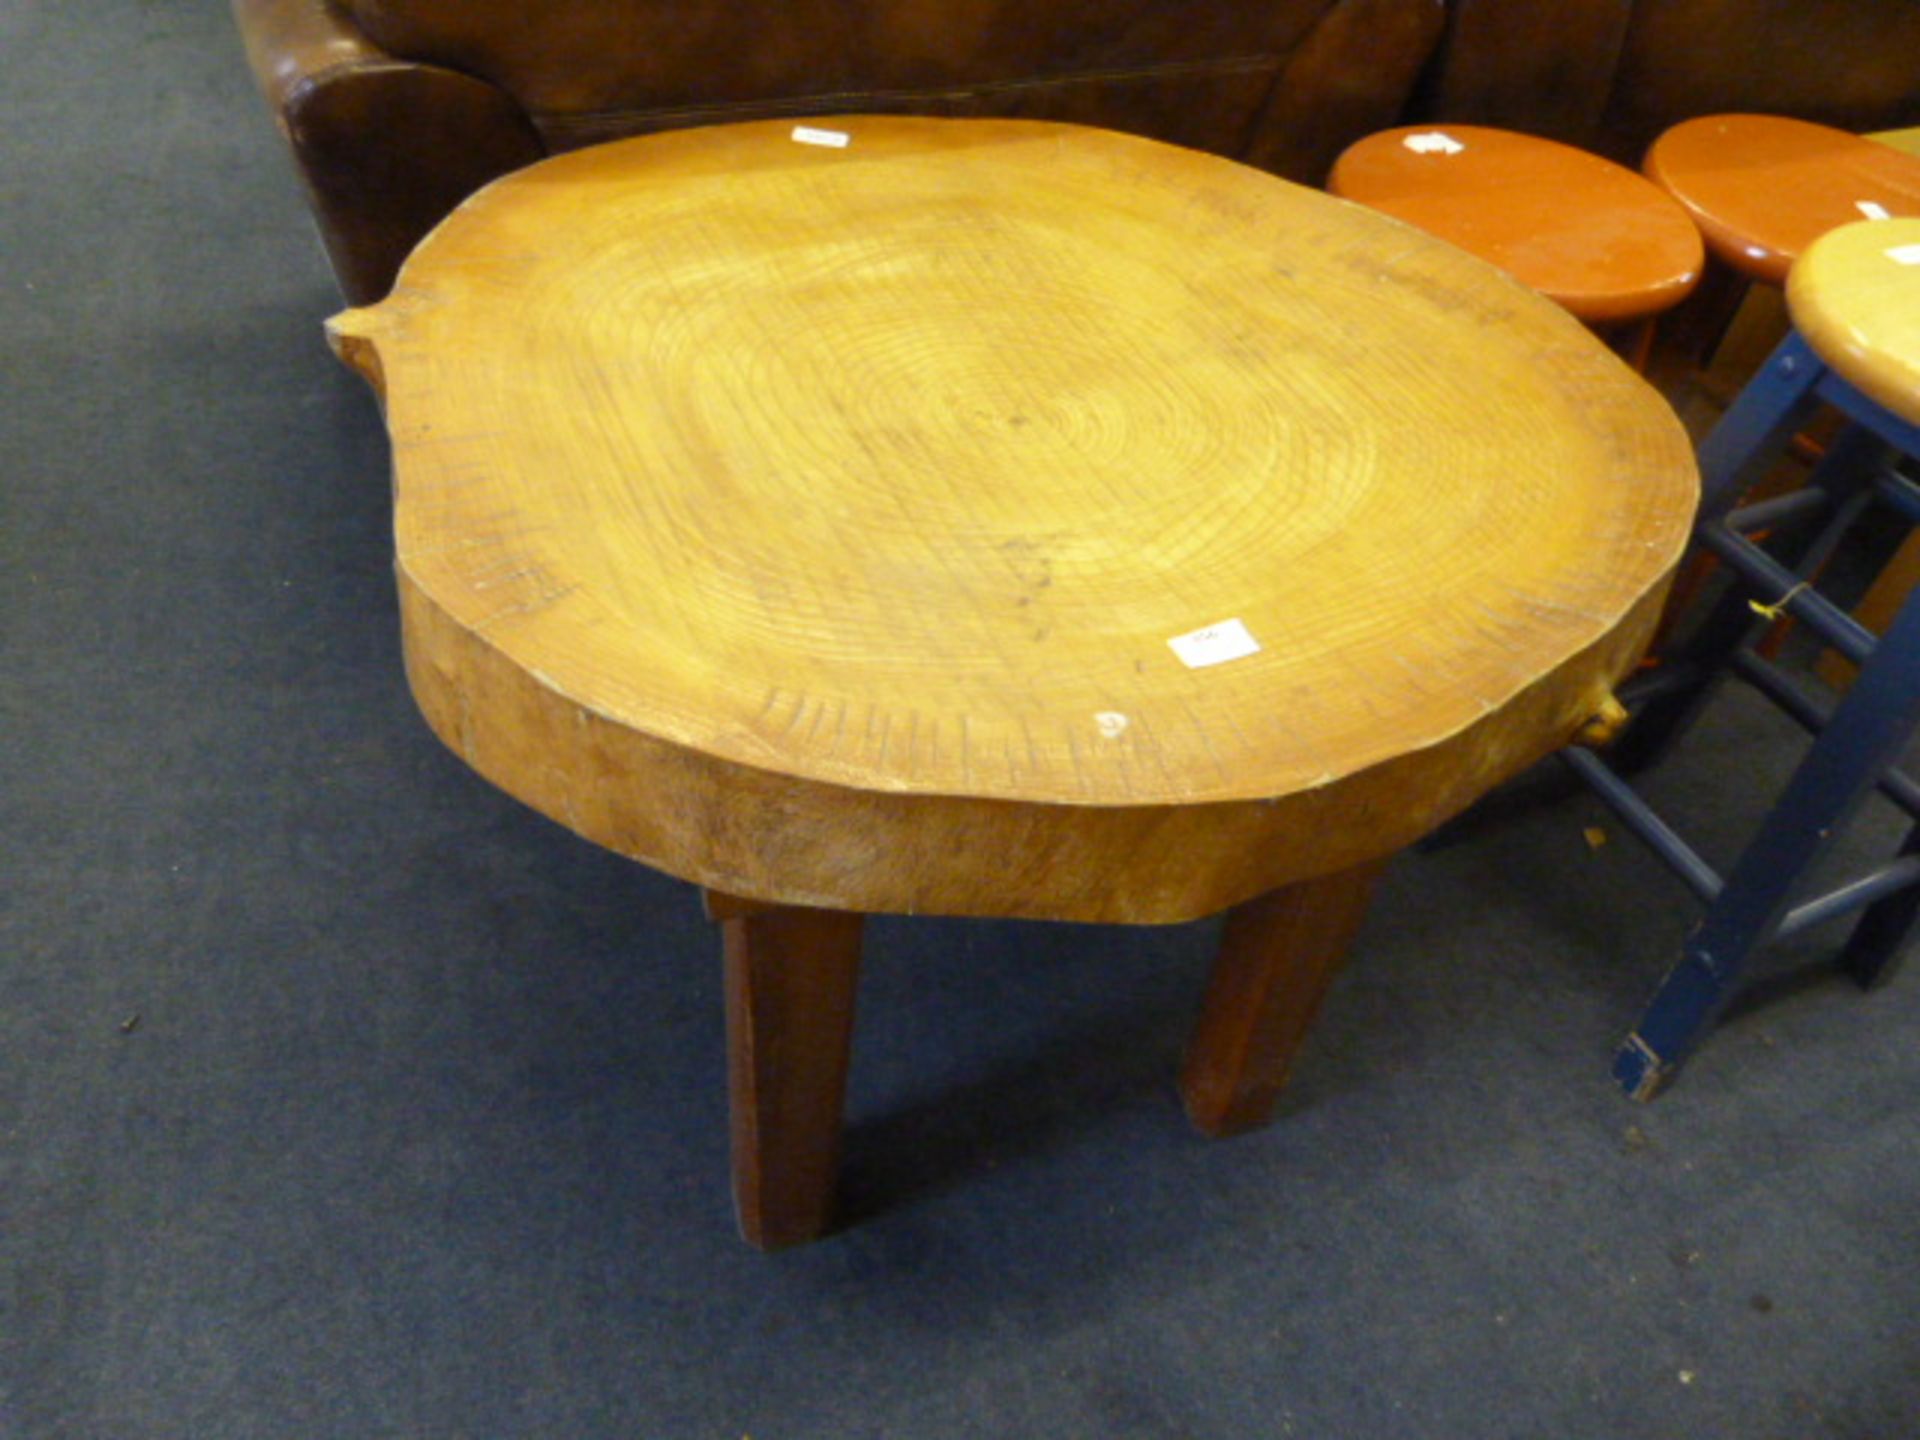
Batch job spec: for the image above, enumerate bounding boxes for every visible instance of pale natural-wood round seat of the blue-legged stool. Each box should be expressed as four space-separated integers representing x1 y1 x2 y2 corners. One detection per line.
1788 219 1920 424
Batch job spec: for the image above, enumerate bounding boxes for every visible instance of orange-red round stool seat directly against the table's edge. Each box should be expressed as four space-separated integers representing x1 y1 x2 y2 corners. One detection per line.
1327 125 1703 324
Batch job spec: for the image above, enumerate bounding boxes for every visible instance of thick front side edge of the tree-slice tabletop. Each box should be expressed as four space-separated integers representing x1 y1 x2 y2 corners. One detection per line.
399 572 1670 925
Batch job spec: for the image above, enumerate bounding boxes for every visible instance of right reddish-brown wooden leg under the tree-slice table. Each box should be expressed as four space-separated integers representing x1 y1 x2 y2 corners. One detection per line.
1181 862 1384 1135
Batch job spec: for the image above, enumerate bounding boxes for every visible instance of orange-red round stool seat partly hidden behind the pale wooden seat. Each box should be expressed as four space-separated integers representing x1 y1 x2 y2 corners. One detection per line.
1647 115 1920 284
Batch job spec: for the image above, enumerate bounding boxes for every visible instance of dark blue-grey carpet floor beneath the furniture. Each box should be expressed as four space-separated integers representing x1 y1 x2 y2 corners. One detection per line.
0 0 1920 1440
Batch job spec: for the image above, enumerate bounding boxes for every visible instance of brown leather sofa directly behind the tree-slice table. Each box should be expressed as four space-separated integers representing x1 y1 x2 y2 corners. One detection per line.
234 0 1444 301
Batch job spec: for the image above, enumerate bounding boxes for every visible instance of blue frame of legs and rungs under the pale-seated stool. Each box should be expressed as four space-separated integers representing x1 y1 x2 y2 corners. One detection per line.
1563 334 1920 1100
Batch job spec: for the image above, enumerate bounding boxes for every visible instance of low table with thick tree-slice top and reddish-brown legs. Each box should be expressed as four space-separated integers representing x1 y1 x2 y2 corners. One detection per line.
330 117 1697 1246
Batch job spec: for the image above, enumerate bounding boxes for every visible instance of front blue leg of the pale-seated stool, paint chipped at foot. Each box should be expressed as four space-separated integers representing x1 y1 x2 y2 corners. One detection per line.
1613 568 1920 1100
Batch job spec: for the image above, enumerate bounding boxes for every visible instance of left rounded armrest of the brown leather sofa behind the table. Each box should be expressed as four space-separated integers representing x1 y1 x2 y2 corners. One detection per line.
232 0 545 305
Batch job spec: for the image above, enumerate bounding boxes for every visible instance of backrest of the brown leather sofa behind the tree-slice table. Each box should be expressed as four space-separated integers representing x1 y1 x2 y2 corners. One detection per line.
342 0 1413 154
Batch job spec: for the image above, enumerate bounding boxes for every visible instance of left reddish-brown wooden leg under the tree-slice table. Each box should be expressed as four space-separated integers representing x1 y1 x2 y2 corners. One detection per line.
707 893 862 1250
